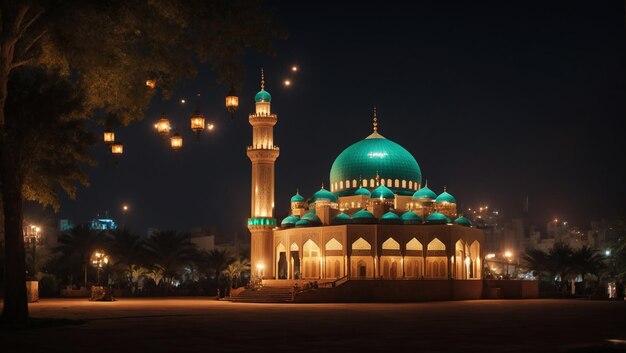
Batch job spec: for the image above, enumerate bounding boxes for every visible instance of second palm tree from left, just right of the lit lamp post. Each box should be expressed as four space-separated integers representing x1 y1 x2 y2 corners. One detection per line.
109 227 146 290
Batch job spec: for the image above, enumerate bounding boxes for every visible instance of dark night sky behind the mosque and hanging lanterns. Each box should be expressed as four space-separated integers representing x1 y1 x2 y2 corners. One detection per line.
31 1 626 237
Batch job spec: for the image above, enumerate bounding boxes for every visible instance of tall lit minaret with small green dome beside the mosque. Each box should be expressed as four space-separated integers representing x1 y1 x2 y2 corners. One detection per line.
248 69 280 278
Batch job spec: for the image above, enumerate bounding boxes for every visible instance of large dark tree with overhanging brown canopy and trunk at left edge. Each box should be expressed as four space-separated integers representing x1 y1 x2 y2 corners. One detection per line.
0 0 279 323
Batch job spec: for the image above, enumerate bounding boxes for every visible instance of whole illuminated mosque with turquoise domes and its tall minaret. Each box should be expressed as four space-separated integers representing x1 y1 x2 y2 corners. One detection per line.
247 76 484 281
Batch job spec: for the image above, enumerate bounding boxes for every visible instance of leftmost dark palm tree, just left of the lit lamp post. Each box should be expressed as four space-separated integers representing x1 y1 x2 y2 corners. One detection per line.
55 224 108 288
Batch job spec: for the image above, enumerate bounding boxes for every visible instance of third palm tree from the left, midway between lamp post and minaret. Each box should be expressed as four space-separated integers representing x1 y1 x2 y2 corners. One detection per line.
145 230 197 290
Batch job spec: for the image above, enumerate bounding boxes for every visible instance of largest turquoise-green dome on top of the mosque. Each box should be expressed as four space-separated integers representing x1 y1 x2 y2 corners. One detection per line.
330 132 422 196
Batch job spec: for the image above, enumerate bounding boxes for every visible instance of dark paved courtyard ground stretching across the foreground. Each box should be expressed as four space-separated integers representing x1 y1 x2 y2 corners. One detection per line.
0 298 626 353
